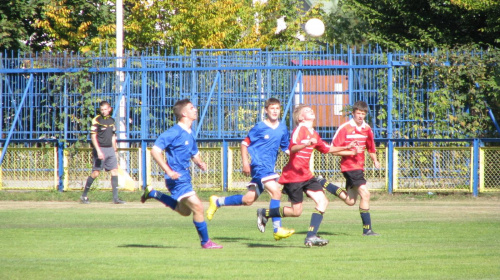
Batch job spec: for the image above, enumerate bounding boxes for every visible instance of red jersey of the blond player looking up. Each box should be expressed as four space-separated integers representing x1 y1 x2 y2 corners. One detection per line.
278 124 330 185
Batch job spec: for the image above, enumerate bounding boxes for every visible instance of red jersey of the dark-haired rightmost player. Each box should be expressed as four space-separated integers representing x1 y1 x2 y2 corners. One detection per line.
332 120 377 172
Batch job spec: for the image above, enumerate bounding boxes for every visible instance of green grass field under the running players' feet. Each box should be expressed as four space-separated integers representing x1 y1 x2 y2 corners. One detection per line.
0 194 500 280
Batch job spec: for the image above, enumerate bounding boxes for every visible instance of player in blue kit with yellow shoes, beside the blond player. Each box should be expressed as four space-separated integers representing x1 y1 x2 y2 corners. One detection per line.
207 98 295 240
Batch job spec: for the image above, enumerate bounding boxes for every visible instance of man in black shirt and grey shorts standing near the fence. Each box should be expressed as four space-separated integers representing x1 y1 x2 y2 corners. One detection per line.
80 101 125 204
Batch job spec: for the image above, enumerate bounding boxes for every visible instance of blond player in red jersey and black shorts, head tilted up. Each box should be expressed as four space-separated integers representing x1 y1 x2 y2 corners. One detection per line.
257 104 357 247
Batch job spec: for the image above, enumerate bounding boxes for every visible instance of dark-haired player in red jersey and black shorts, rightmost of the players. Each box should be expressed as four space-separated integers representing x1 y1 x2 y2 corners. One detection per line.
320 101 380 236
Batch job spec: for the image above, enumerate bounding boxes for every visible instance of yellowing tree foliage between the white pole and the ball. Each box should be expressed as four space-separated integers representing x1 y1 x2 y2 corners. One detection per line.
125 0 320 50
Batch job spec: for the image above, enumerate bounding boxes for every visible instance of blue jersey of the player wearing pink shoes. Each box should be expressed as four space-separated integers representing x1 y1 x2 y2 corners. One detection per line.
154 124 199 181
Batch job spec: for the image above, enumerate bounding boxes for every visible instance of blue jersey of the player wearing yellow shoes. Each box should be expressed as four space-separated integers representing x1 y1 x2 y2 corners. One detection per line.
242 122 290 177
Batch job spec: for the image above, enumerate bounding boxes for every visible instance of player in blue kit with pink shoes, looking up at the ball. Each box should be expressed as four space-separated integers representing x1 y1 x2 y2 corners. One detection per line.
141 99 222 249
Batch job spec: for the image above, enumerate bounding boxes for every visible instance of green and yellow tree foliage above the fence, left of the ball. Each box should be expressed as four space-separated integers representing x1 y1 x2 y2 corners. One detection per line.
0 0 324 52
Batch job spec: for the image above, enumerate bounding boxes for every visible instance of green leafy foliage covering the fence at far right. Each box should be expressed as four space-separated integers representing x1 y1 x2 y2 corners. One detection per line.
409 46 500 138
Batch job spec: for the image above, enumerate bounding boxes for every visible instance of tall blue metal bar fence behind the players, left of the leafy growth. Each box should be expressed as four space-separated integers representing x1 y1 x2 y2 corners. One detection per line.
0 47 498 194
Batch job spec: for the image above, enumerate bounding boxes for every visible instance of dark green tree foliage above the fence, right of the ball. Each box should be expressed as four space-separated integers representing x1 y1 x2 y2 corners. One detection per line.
336 0 500 49
